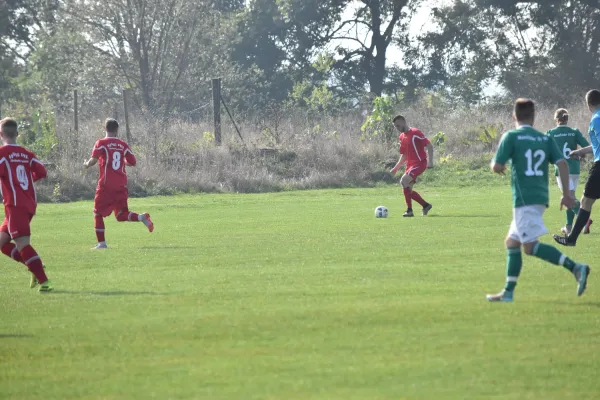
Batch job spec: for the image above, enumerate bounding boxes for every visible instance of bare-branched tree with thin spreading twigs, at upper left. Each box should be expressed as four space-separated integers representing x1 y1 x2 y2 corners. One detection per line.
65 0 244 114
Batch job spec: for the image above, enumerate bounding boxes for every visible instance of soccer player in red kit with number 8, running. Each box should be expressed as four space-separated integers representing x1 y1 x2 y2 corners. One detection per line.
83 118 154 249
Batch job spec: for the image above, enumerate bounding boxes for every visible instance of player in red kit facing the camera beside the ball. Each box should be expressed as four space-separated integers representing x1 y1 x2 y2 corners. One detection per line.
390 115 433 217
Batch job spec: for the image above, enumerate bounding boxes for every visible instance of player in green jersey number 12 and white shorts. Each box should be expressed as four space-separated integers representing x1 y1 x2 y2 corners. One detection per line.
487 99 590 302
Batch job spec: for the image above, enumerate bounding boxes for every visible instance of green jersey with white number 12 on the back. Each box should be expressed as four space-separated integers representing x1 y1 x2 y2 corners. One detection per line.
494 125 564 208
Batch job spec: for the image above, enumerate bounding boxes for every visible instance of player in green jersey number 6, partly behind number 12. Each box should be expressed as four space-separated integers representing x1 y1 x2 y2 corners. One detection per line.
546 108 592 235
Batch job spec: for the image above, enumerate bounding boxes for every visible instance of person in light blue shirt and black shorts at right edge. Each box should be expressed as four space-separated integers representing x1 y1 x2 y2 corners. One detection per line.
554 89 600 246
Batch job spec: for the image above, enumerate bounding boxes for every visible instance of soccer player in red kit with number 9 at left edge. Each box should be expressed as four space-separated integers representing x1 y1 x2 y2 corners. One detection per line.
0 118 54 292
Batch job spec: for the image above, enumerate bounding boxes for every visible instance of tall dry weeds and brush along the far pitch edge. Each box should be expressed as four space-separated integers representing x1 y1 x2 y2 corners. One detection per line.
3 93 589 202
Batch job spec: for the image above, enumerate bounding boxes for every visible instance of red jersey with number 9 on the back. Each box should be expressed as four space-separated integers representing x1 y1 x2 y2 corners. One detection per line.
0 144 47 215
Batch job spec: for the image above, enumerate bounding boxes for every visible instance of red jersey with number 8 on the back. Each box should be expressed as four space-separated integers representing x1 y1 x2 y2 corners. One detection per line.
92 137 136 191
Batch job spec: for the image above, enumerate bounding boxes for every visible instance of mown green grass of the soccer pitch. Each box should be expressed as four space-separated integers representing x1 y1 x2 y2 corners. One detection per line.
0 184 600 399
